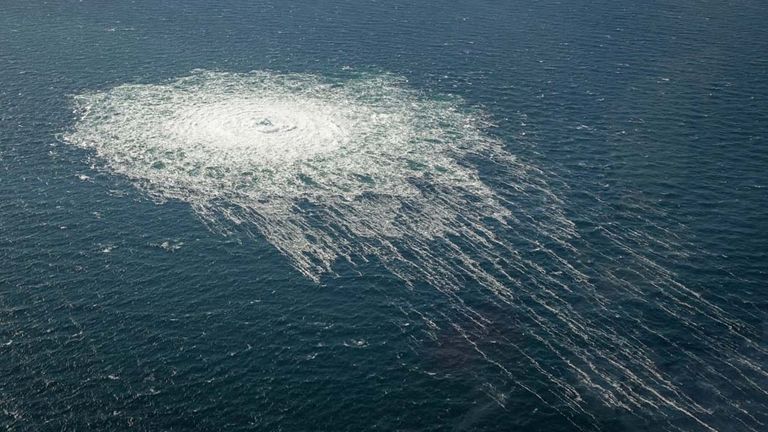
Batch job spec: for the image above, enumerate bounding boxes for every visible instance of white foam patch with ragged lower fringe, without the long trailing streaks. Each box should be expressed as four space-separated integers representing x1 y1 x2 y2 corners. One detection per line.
65 72 512 279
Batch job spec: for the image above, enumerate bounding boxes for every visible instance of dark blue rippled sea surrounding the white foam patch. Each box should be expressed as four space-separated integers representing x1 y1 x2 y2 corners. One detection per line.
0 0 768 431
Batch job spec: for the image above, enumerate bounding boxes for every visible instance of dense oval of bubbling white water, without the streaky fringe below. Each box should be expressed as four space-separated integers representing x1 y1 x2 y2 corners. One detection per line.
65 72 488 207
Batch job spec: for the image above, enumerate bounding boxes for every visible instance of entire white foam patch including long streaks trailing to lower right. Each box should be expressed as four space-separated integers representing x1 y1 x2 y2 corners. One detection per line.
64 71 768 430
